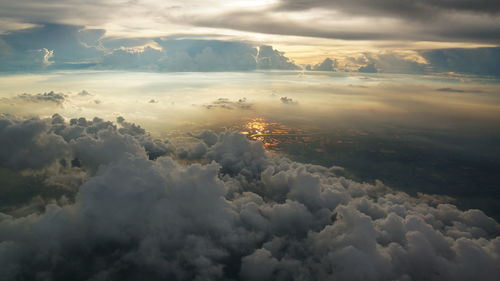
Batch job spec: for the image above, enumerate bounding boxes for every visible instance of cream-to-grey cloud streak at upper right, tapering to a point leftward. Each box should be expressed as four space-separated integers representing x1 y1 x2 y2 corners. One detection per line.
190 3 500 44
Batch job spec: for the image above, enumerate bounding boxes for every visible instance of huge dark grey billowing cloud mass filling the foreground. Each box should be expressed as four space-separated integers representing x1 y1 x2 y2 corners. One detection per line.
0 115 500 281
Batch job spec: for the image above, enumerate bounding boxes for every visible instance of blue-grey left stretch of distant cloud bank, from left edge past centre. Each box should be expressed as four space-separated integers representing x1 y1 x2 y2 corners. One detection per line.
0 24 298 72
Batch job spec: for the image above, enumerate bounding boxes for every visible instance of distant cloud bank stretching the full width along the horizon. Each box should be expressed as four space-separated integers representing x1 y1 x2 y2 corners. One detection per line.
0 24 500 76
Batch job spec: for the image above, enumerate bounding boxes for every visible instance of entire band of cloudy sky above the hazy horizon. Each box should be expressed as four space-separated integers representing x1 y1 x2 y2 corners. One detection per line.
0 0 500 75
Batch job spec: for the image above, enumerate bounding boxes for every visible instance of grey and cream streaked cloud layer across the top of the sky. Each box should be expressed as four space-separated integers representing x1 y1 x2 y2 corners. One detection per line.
0 0 500 48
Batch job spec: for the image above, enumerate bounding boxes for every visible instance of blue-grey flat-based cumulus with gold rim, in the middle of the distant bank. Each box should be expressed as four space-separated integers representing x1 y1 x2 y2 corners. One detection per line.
99 38 298 72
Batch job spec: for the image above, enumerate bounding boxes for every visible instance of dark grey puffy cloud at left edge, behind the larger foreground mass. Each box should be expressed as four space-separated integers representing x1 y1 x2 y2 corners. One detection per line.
0 114 172 171
